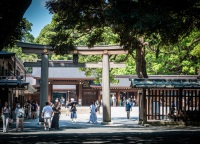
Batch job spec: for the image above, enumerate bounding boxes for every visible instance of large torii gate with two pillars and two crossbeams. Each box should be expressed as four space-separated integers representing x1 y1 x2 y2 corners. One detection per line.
17 42 127 124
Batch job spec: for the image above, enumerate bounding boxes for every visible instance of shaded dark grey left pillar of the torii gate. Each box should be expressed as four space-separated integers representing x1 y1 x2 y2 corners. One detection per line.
39 53 49 122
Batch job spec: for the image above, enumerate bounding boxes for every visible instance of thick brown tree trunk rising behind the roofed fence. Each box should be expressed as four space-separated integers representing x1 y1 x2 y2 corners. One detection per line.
136 46 148 78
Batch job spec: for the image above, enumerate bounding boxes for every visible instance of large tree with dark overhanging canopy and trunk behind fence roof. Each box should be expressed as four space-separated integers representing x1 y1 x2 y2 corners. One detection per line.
46 0 200 77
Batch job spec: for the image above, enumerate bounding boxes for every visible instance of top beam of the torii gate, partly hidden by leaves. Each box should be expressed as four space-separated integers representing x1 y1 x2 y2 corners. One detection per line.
17 42 128 55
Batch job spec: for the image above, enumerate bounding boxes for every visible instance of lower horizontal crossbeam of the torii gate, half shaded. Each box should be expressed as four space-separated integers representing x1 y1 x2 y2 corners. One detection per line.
24 62 126 68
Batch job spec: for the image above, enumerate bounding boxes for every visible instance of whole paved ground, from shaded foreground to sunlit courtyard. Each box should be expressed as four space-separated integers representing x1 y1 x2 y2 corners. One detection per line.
0 107 200 144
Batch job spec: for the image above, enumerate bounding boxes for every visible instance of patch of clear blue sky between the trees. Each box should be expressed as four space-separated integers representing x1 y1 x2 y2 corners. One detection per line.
23 0 52 38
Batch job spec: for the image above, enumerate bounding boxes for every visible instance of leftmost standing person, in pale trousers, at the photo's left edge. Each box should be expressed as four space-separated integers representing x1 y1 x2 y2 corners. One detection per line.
1 102 11 133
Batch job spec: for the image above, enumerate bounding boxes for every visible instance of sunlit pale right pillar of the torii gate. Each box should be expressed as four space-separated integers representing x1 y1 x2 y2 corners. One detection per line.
102 54 112 124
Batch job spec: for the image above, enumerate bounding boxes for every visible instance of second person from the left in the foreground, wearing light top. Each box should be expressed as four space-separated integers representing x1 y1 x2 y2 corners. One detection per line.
15 103 25 132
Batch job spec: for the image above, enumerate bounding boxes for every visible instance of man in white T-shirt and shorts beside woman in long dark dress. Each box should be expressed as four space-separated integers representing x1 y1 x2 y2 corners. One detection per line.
41 102 53 130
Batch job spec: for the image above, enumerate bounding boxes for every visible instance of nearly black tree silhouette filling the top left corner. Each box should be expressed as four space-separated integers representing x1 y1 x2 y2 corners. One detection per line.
0 0 32 50
